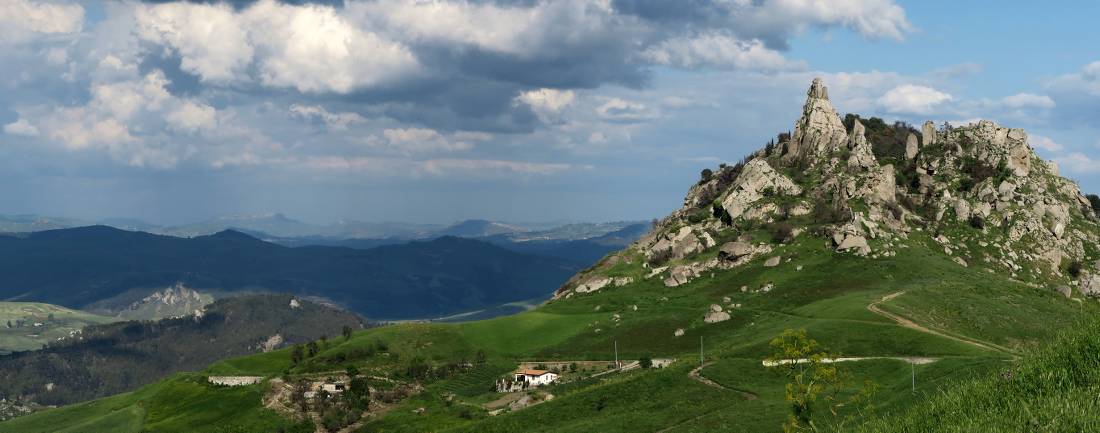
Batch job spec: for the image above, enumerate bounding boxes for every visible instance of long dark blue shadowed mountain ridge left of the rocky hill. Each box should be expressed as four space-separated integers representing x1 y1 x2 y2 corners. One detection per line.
0 226 579 319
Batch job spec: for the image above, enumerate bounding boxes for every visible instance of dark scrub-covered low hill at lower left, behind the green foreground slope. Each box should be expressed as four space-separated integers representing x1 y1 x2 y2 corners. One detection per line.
0 295 364 404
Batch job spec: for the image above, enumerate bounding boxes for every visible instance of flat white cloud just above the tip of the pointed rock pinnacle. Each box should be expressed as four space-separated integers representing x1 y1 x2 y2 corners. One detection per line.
641 32 805 71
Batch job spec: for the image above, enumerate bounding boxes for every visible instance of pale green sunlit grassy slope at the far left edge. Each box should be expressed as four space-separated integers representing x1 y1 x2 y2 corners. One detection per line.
0 302 119 354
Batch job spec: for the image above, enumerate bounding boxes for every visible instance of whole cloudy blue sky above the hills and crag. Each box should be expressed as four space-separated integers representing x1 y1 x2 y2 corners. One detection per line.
0 0 1100 224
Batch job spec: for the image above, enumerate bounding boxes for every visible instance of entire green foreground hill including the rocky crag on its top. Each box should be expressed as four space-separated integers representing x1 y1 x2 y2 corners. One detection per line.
0 80 1100 432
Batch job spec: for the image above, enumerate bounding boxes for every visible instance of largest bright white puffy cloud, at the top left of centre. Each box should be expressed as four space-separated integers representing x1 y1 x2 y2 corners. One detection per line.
135 0 419 93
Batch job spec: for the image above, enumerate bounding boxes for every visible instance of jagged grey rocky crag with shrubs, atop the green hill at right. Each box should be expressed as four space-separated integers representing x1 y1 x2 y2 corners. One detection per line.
554 79 1100 299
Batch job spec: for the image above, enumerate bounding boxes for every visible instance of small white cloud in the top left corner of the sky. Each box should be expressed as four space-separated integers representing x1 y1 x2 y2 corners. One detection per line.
0 0 84 43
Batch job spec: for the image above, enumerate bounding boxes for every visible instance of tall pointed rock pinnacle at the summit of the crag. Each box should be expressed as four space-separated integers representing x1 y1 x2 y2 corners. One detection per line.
783 78 848 160
